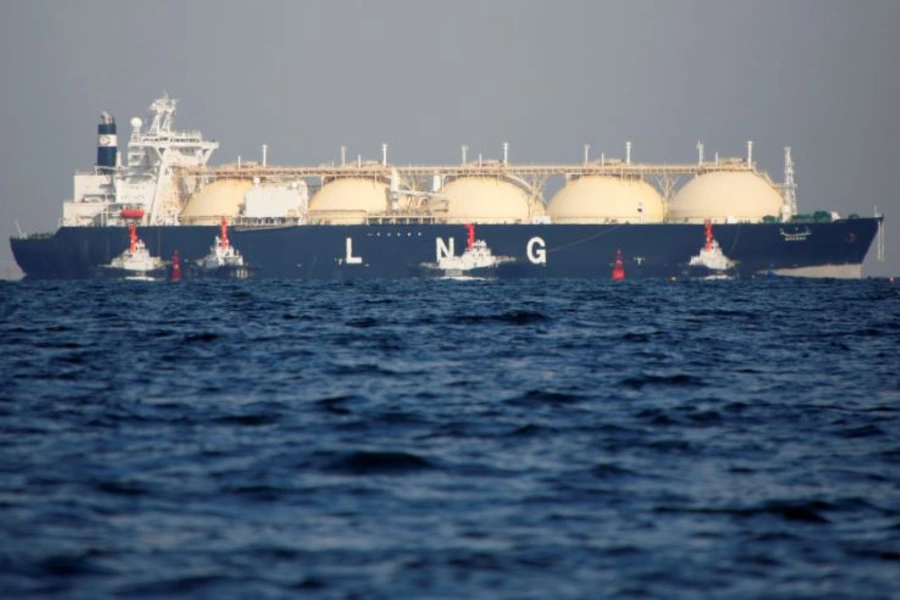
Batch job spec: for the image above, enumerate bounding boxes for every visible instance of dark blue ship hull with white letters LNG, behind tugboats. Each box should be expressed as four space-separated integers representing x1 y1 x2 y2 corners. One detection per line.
11 218 879 279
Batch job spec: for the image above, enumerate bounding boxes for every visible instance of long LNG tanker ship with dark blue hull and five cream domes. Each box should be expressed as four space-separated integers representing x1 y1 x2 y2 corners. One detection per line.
11 96 883 279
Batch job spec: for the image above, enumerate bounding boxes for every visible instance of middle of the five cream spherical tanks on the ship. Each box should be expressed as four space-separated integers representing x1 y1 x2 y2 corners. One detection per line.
429 177 532 223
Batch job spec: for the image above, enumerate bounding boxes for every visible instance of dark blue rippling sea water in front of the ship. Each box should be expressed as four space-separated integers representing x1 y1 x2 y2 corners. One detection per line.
0 280 900 599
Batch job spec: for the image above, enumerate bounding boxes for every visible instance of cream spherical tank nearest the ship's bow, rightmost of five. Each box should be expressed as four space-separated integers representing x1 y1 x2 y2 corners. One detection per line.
668 171 783 223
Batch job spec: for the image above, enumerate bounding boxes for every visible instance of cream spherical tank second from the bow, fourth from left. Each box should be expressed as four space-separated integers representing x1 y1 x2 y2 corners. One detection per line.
547 175 665 223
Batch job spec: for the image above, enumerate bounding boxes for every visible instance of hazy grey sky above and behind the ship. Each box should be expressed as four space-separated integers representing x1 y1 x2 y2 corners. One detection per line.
0 0 900 277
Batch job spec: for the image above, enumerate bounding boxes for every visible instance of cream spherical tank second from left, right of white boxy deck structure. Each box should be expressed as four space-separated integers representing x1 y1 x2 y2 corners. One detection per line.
309 177 389 225
